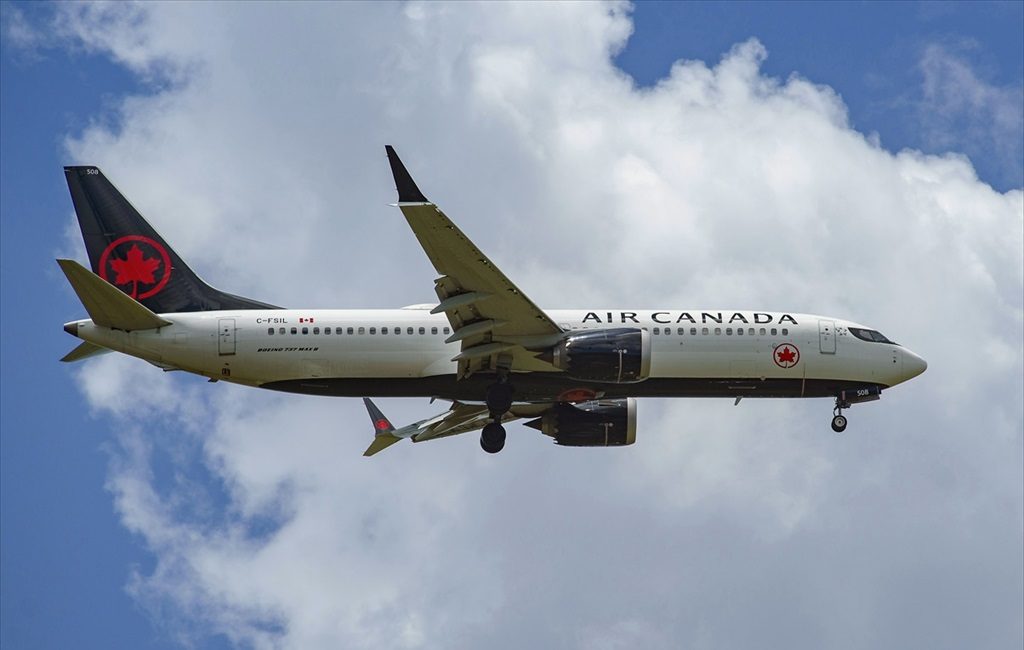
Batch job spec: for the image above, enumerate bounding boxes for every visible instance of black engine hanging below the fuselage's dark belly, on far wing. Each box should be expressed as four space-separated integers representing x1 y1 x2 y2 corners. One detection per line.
526 397 637 447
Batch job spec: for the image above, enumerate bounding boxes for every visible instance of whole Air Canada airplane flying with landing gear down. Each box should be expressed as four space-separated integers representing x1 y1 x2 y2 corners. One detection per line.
57 145 928 456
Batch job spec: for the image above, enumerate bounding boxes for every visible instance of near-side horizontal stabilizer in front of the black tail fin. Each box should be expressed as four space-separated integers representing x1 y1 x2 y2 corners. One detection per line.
57 260 171 332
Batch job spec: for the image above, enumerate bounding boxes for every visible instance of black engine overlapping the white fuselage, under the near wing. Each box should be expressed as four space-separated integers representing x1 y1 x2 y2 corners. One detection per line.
541 328 650 384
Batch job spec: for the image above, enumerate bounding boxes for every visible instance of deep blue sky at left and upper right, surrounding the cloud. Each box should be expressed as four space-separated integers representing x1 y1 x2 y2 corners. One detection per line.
0 2 1024 648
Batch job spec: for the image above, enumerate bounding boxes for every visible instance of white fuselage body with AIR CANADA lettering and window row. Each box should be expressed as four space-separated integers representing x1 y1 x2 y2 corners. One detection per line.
70 306 924 399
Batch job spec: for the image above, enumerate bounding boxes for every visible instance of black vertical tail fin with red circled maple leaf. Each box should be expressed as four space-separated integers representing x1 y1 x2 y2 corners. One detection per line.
65 167 280 313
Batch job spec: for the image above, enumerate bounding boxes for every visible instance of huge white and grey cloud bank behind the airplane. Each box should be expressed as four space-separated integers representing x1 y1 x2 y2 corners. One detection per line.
49 3 1024 648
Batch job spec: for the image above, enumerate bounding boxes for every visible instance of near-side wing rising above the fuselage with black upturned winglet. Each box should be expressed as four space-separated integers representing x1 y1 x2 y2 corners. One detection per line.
385 145 562 378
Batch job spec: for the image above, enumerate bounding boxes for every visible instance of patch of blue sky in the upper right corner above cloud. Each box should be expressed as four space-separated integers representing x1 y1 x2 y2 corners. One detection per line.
617 2 1024 190
